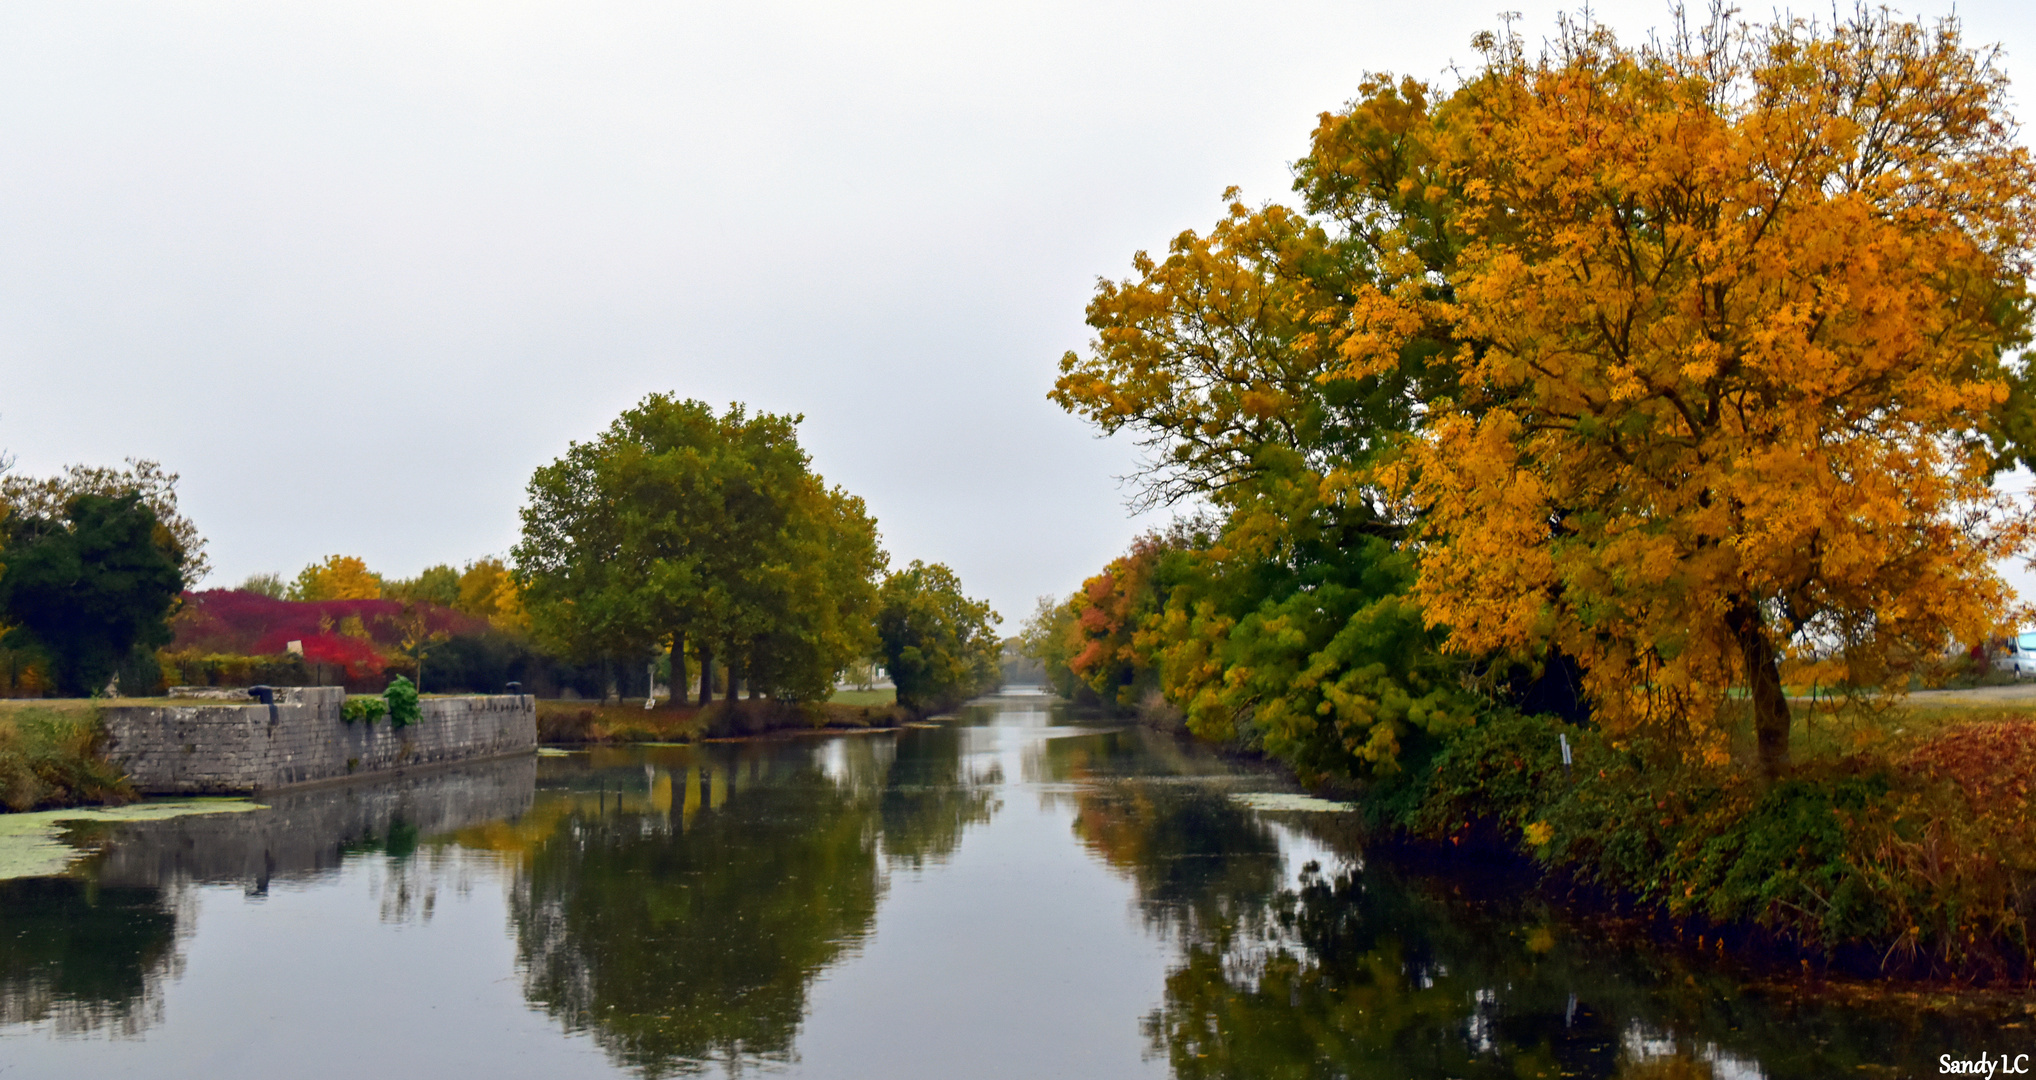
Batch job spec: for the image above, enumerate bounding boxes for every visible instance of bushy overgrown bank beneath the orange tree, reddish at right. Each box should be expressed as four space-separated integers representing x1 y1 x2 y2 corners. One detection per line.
1364 705 2036 984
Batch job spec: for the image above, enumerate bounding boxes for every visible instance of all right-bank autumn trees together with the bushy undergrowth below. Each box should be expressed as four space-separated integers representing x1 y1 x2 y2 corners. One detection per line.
1026 8 2036 974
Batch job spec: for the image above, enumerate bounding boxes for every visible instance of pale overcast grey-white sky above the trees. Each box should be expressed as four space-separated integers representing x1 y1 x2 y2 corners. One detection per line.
0 0 2036 630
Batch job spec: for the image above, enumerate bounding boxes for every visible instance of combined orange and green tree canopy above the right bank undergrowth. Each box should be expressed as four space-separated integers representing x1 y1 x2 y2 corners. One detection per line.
1053 10 2036 770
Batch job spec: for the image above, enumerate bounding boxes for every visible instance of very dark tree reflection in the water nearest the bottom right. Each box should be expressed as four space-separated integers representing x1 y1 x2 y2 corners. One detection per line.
1144 815 1995 1080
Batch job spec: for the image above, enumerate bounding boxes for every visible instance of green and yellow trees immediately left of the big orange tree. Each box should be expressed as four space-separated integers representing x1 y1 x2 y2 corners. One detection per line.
1053 178 1474 774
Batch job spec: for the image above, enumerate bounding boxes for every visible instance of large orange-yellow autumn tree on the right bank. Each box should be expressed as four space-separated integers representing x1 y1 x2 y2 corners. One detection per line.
1400 14 2036 772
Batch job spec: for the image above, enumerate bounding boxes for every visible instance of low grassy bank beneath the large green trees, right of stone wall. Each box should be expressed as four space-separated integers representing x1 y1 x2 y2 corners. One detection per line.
538 699 904 744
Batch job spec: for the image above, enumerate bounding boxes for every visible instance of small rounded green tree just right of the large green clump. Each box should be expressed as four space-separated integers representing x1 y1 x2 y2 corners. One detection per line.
878 558 1004 709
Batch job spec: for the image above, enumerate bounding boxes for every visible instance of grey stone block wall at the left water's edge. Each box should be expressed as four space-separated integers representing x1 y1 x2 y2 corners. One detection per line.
100 687 538 795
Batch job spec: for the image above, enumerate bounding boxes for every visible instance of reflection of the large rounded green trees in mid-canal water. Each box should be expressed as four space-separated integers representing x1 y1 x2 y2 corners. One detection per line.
496 732 1000 1076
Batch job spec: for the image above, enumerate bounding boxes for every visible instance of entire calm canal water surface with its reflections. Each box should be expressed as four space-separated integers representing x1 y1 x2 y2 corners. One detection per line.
0 695 2036 1080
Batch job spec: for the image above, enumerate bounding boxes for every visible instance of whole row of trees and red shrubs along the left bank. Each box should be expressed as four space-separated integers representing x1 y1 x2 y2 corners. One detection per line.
0 393 1002 709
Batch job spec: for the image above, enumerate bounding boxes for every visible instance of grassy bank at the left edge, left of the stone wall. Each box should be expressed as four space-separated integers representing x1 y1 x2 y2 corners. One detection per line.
0 701 134 811
